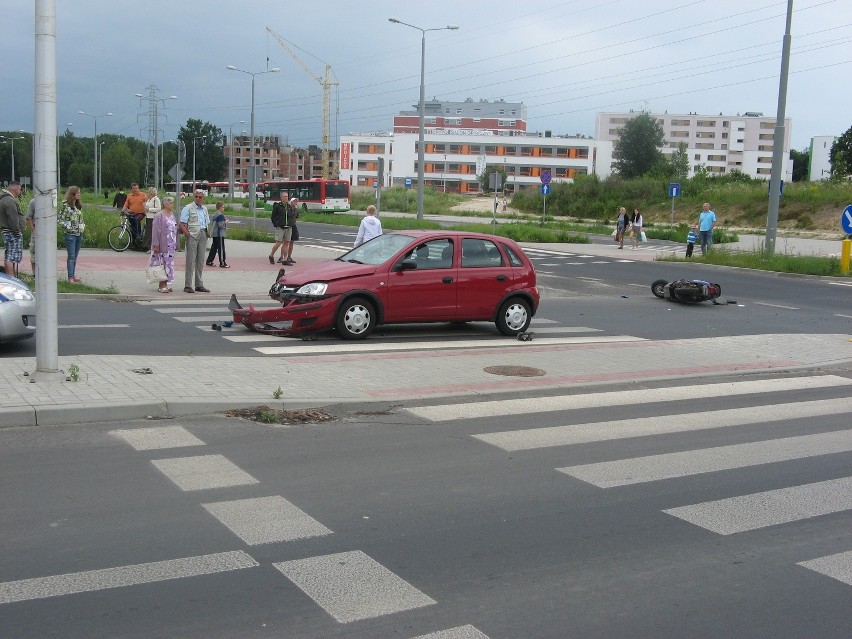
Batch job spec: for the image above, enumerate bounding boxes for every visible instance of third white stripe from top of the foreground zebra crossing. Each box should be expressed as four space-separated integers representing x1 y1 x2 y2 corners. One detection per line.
556 430 852 488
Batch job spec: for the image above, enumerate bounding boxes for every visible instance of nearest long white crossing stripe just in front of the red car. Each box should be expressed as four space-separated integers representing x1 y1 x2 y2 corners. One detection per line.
255 335 644 355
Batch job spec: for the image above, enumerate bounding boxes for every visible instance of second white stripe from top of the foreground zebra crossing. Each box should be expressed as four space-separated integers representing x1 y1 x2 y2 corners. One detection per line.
474 397 849 451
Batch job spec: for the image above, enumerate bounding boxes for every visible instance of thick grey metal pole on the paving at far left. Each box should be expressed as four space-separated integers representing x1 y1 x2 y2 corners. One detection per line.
31 0 62 382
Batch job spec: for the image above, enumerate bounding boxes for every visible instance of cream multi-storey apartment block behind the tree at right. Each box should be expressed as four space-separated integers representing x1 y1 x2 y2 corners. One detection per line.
595 111 793 182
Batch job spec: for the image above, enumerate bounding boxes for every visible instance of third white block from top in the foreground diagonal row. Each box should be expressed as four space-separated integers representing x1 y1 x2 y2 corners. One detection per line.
202 496 332 546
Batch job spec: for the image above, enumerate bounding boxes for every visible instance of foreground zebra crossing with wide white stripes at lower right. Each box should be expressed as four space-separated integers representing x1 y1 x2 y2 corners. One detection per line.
406 375 852 585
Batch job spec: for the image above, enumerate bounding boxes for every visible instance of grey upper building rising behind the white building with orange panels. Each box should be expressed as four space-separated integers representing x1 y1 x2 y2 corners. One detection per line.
393 98 527 136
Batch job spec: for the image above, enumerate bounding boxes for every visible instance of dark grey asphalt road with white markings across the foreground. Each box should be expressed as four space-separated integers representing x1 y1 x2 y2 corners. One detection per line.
0 375 852 639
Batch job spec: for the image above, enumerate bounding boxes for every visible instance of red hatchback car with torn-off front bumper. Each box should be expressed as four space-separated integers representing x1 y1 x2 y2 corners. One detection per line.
229 231 539 339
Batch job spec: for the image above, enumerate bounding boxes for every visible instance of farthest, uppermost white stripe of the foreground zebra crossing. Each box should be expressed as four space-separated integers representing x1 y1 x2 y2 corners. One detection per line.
407 375 852 421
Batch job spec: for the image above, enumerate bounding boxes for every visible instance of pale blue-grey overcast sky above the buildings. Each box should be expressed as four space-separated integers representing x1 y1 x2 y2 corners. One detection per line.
0 0 852 149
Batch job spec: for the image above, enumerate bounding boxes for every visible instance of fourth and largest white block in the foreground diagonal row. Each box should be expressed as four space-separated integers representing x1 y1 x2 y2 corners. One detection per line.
272 550 436 623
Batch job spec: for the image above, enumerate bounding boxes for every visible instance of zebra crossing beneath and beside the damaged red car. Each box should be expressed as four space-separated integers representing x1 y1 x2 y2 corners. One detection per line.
136 297 645 356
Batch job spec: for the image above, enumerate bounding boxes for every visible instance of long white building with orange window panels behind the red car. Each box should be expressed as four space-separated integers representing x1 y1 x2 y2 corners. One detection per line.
340 130 612 193
